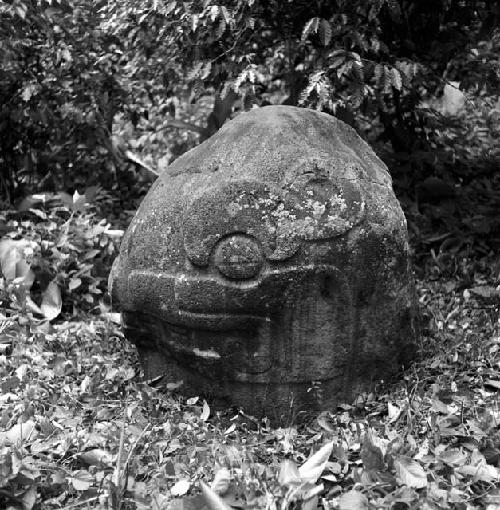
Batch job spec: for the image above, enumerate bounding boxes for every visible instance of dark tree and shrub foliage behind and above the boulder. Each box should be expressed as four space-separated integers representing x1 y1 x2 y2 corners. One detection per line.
0 0 500 248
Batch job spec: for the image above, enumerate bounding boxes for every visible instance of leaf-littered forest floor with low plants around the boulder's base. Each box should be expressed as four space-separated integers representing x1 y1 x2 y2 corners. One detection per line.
0 196 500 510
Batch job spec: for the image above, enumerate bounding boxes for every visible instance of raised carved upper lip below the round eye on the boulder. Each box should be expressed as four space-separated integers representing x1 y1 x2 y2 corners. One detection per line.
124 265 338 331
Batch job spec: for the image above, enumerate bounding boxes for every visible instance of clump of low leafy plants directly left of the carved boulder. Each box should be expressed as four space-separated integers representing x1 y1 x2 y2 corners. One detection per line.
0 188 123 321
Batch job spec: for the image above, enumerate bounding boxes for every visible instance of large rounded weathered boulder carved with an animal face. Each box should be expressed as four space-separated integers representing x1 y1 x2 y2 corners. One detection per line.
110 106 415 417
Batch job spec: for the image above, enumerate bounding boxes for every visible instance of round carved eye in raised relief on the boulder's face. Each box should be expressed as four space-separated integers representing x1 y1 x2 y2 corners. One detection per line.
215 234 263 280
